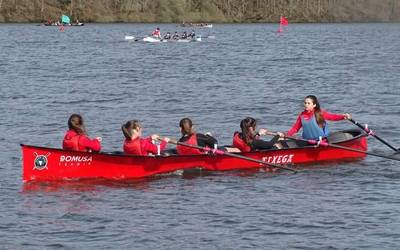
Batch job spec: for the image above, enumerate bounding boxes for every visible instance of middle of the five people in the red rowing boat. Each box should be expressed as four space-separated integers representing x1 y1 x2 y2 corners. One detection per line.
176 118 218 155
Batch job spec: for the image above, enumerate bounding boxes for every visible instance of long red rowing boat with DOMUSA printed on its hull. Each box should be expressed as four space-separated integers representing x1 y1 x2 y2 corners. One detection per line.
21 130 367 182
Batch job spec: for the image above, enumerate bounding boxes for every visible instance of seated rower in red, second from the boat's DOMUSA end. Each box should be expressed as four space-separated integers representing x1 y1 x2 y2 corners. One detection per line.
121 120 169 155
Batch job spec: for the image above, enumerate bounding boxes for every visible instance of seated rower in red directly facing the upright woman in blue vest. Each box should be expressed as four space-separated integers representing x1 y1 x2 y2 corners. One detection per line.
233 117 286 152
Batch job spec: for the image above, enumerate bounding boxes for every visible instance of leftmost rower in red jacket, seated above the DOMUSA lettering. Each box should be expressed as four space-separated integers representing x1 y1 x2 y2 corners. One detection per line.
63 114 102 152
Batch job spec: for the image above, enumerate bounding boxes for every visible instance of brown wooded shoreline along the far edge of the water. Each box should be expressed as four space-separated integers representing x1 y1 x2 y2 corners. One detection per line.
0 0 400 24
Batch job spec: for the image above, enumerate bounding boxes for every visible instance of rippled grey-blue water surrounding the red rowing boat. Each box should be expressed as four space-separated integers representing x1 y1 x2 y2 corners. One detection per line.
0 24 400 249
